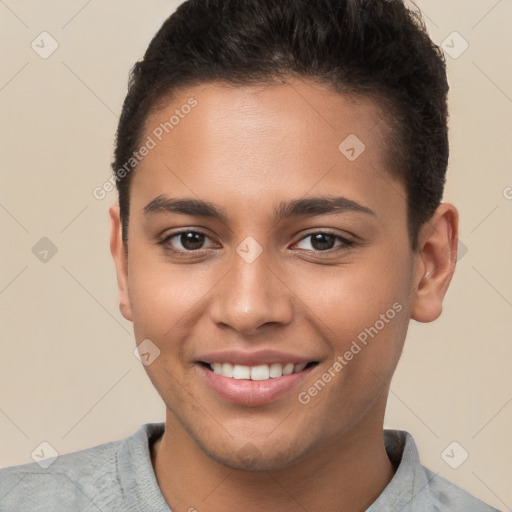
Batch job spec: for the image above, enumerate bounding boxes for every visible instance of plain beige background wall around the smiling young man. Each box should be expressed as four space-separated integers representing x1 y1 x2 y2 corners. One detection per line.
0 0 512 510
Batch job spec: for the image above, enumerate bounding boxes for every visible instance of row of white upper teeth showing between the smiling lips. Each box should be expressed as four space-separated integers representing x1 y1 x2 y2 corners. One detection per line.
200 361 318 380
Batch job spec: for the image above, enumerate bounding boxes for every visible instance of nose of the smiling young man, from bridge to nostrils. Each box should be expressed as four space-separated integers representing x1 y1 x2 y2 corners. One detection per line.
210 251 293 335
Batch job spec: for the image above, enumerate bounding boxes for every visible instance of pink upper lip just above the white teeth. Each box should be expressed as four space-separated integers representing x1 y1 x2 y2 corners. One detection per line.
198 350 318 366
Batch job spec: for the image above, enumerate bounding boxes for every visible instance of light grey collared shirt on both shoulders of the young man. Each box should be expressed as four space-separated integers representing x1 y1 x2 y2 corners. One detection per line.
0 423 497 512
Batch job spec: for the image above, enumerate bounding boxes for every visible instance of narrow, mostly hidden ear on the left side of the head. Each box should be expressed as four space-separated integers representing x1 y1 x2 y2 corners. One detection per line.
109 203 132 321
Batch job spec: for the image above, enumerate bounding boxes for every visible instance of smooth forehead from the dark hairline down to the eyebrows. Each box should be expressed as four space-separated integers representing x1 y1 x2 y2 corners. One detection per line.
132 80 403 223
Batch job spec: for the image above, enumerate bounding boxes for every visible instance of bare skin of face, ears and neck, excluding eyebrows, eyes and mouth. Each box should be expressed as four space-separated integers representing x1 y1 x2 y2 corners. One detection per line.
110 79 458 512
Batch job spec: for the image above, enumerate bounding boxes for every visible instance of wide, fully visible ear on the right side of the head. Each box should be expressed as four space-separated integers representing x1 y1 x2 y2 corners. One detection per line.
411 203 459 322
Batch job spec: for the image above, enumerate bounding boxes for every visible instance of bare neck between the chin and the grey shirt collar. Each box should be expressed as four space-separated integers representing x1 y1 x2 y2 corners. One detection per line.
152 404 394 512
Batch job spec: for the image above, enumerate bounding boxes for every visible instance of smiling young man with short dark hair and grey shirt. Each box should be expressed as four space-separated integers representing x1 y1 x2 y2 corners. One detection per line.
0 0 504 512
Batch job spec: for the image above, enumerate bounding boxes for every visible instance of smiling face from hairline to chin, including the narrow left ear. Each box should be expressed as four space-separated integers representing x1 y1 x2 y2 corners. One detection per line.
111 81 444 469
